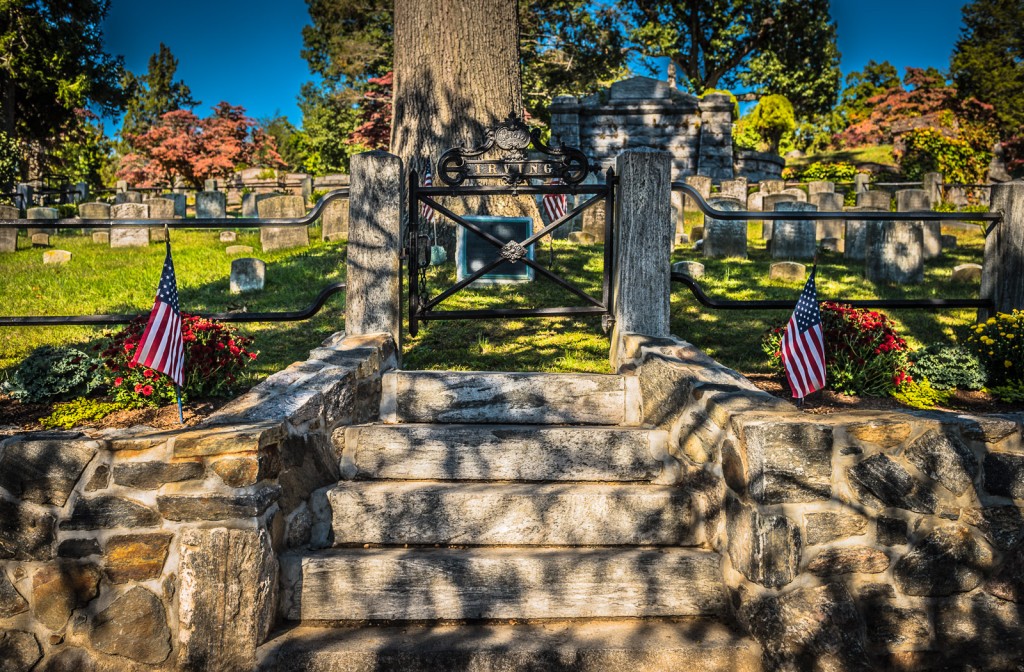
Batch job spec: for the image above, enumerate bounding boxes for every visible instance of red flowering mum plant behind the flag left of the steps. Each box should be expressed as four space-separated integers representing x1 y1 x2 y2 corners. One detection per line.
102 313 258 408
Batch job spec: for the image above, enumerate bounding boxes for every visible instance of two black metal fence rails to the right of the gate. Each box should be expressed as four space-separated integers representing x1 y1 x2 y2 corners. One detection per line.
672 182 1002 312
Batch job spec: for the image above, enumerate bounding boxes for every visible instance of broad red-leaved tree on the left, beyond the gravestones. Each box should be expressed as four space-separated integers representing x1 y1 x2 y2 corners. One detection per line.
118 102 285 188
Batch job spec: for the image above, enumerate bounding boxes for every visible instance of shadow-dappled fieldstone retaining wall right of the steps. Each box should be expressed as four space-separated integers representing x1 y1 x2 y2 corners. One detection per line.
626 336 1024 670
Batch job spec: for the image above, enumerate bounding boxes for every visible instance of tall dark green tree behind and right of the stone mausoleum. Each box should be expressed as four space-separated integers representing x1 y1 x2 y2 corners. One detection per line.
629 0 840 117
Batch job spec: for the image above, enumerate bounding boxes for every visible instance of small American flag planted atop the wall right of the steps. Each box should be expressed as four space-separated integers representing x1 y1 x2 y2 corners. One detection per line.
780 268 825 398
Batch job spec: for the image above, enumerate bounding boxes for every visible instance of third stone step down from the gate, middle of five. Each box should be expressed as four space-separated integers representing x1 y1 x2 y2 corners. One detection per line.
327 481 700 546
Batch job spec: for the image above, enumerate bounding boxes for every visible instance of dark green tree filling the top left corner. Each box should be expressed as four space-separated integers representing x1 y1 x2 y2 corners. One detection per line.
0 0 124 177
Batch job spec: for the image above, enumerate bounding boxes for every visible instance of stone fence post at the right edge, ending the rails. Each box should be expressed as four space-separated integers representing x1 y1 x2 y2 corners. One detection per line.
981 180 1024 317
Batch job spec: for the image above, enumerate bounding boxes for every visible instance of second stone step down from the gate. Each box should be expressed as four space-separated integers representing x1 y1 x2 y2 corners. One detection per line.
334 424 676 481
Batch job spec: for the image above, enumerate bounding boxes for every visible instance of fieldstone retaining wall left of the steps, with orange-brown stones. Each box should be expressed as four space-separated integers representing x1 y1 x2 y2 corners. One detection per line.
0 333 395 672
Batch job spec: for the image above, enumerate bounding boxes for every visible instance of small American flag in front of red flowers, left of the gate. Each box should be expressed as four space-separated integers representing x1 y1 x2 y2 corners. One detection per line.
132 241 185 387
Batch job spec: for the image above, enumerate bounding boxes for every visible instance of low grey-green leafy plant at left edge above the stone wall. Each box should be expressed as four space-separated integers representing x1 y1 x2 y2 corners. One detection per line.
3 345 102 403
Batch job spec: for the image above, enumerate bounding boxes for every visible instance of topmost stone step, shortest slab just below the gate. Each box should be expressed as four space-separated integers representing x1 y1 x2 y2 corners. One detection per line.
381 371 640 425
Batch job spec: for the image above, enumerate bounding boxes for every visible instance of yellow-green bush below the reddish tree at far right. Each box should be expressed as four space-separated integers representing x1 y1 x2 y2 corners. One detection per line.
900 128 992 184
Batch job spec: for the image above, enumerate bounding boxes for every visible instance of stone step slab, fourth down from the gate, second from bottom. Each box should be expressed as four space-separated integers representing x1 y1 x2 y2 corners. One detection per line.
281 548 727 625
